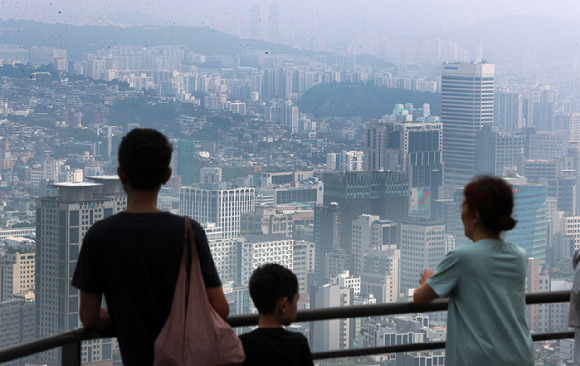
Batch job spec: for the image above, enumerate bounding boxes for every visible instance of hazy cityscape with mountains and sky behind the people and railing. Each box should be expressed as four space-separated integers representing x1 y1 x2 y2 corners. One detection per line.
0 0 580 366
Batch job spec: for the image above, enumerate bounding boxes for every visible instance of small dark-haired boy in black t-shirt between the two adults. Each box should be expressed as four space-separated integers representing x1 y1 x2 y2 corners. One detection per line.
240 263 313 366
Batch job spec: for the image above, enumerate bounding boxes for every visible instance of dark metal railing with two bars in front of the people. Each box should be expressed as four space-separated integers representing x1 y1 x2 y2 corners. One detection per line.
0 291 574 366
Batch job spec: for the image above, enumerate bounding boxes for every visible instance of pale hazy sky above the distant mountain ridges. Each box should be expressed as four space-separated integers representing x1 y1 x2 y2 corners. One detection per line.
0 0 580 36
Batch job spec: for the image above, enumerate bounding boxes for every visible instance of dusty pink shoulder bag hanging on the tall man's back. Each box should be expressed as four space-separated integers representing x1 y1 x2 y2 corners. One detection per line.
154 216 245 366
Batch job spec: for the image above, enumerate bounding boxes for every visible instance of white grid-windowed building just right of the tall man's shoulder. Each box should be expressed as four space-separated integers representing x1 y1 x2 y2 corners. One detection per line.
179 184 256 239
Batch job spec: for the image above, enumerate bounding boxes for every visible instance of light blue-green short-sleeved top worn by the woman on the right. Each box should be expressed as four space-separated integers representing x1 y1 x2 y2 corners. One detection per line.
427 239 534 366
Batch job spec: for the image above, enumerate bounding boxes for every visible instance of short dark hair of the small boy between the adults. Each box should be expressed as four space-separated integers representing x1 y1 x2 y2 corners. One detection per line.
248 263 298 314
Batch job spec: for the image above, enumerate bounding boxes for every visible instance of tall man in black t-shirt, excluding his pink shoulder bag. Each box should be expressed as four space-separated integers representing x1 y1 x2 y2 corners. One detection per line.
72 128 229 366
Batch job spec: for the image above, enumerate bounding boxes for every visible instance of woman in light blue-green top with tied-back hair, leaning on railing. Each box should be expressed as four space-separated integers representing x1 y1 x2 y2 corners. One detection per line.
413 176 534 366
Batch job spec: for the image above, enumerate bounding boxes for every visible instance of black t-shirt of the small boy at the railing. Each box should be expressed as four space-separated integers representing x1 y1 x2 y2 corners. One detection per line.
240 328 314 366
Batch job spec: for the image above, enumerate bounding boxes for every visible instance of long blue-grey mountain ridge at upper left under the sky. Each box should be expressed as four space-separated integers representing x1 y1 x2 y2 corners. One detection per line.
0 20 300 60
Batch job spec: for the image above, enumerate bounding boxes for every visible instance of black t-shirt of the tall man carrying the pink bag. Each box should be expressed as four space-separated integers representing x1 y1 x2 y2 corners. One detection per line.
72 212 221 366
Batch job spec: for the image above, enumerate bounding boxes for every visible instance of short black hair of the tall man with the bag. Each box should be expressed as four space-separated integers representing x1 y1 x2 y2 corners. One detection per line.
117 128 173 190
